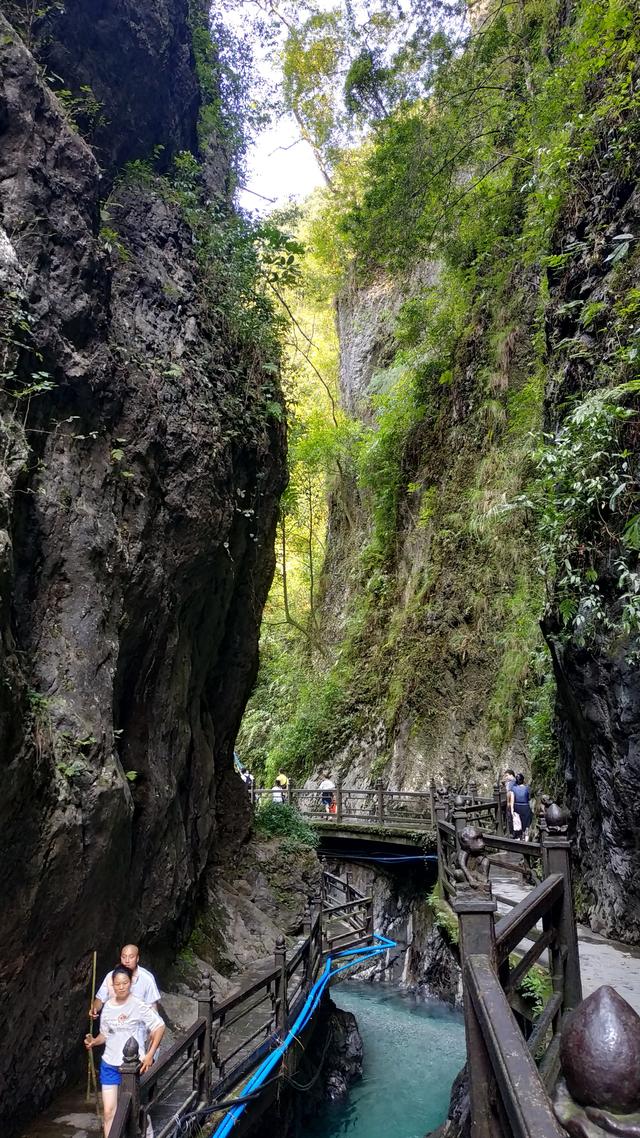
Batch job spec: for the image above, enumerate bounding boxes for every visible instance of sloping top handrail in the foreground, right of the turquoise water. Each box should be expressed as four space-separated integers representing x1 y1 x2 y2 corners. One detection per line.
465 954 566 1138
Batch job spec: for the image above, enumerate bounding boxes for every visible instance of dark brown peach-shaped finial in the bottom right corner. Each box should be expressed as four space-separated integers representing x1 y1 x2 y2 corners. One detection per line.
553 984 640 1138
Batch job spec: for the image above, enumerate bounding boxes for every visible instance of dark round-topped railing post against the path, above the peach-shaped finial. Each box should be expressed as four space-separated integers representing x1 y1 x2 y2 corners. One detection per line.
540 830 582 1012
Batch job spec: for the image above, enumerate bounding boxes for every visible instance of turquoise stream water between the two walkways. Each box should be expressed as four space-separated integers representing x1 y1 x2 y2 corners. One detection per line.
303 983 465 1138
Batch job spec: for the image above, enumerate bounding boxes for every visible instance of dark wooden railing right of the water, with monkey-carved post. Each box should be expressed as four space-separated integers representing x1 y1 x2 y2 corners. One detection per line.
446 818 582 1138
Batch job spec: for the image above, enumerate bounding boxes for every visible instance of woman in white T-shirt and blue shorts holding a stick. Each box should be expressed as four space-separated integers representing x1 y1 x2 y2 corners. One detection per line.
84 964 165 1138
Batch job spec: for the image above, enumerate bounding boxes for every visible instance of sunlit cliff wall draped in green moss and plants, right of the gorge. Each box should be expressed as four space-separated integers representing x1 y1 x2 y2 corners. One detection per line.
294 5 640 942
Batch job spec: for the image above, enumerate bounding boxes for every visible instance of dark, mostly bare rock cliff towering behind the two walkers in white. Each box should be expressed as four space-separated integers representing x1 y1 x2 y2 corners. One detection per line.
0 0 284 1133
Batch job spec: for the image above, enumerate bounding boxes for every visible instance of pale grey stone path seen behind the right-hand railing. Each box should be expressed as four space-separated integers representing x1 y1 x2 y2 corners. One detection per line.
491 869 640 1014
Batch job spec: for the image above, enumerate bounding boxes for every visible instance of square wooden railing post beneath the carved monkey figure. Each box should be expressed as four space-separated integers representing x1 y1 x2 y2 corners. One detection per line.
453 889 502 1138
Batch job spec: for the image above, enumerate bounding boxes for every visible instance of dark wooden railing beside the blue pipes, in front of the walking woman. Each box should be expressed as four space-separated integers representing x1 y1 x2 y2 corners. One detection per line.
110 873 374 1138
